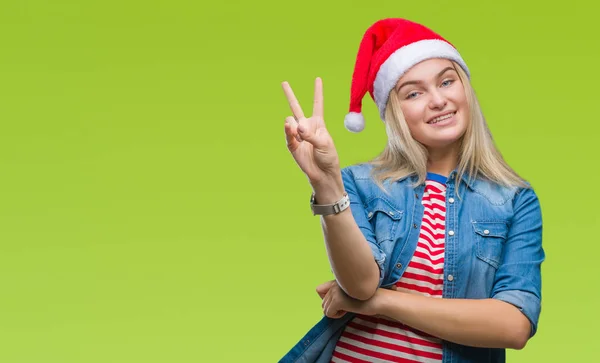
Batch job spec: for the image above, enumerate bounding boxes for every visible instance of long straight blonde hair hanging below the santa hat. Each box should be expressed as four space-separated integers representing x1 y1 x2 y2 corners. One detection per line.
369 62 528 195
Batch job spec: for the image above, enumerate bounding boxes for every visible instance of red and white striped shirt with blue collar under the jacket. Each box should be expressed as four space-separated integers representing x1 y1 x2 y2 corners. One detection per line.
331 173 446 363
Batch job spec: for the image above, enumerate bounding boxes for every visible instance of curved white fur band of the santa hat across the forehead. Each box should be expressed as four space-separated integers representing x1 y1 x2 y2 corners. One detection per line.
373 39 469 120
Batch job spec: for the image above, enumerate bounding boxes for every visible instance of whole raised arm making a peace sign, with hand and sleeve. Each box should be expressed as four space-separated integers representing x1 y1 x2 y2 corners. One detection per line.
282 78 383 300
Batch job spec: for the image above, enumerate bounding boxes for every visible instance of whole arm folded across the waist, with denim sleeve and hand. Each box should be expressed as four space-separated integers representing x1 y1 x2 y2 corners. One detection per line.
323 189 544 349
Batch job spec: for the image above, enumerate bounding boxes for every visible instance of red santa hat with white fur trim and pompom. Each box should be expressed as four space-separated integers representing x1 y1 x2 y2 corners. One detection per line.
344 18 470 132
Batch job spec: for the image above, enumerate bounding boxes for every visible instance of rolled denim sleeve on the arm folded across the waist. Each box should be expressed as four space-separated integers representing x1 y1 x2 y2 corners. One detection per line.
492 189 545 337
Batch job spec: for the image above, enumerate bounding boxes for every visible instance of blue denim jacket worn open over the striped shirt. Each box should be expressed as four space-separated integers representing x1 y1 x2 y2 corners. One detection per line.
280 164 545 363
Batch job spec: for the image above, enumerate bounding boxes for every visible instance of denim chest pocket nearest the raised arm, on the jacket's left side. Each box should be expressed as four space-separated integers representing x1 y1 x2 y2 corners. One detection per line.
365 198 404 244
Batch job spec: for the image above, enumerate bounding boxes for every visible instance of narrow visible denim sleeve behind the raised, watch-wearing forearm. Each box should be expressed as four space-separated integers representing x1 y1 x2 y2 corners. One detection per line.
342 168 386 287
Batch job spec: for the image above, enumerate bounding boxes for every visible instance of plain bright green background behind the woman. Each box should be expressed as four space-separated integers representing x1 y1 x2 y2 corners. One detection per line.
0 0 600 363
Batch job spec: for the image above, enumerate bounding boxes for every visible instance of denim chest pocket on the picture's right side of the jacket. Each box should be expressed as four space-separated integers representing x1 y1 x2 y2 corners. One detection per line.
473 221 508 269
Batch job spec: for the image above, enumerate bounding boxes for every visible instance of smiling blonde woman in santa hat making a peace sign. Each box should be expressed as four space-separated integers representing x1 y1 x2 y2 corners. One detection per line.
281 19 544 362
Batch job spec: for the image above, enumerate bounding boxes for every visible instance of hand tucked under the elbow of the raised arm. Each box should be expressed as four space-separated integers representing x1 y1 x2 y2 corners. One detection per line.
317 280 377 319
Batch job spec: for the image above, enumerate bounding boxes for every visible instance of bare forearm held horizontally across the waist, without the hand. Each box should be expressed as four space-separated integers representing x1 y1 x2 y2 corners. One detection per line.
374 289 531 349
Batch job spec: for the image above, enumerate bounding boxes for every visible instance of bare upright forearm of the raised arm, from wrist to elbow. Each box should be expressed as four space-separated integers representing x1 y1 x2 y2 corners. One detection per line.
315 182 379 300
